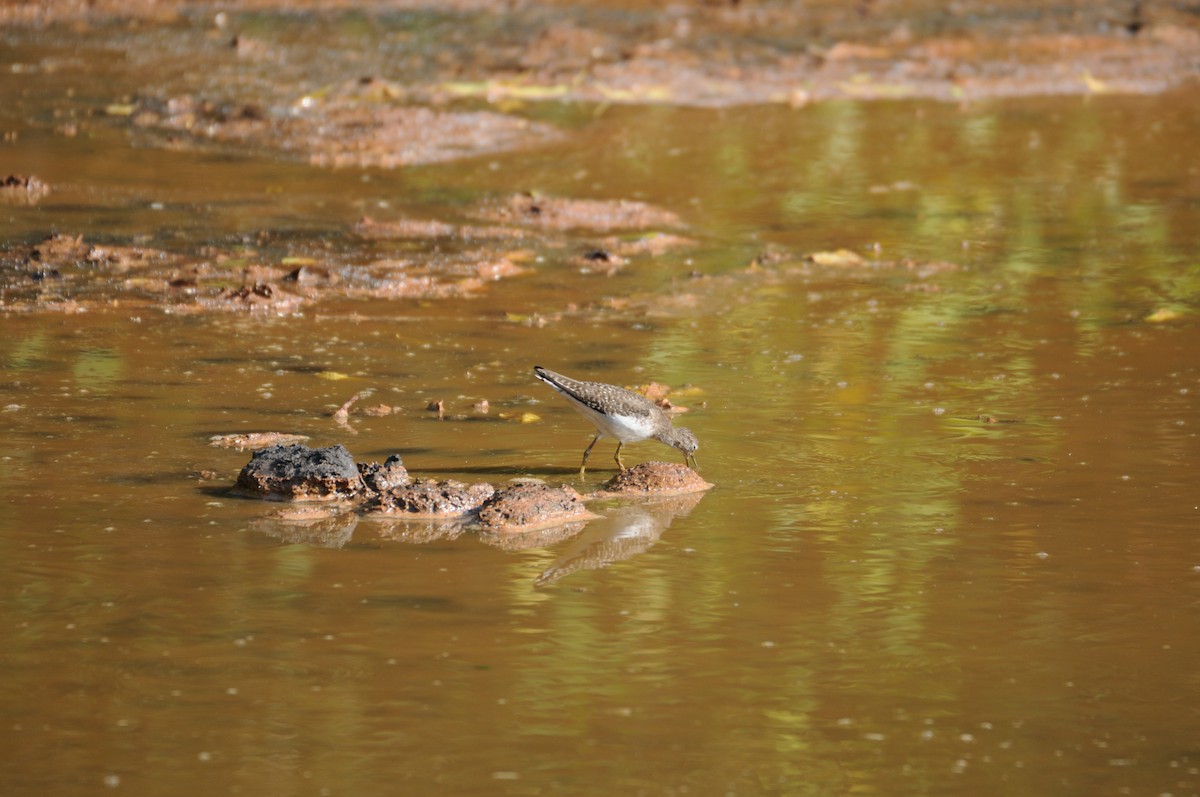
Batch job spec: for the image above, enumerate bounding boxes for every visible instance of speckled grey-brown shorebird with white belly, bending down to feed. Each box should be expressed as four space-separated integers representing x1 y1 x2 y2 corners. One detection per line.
533 365 700 474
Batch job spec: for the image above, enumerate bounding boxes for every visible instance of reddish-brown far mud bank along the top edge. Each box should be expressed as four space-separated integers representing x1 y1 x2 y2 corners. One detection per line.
7 0 1200 107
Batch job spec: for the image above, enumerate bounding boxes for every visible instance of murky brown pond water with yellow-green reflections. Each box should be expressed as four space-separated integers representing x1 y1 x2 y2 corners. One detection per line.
0 21 1200 795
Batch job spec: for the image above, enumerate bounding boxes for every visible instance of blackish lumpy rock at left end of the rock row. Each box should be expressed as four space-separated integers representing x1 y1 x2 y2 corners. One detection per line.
238 445 364 501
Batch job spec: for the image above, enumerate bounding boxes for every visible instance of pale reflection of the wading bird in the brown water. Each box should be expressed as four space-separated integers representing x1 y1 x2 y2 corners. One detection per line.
534 492 704 587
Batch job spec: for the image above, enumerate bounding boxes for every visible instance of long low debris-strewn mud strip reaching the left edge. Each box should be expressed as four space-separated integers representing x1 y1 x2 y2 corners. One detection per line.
0 234 552 314
